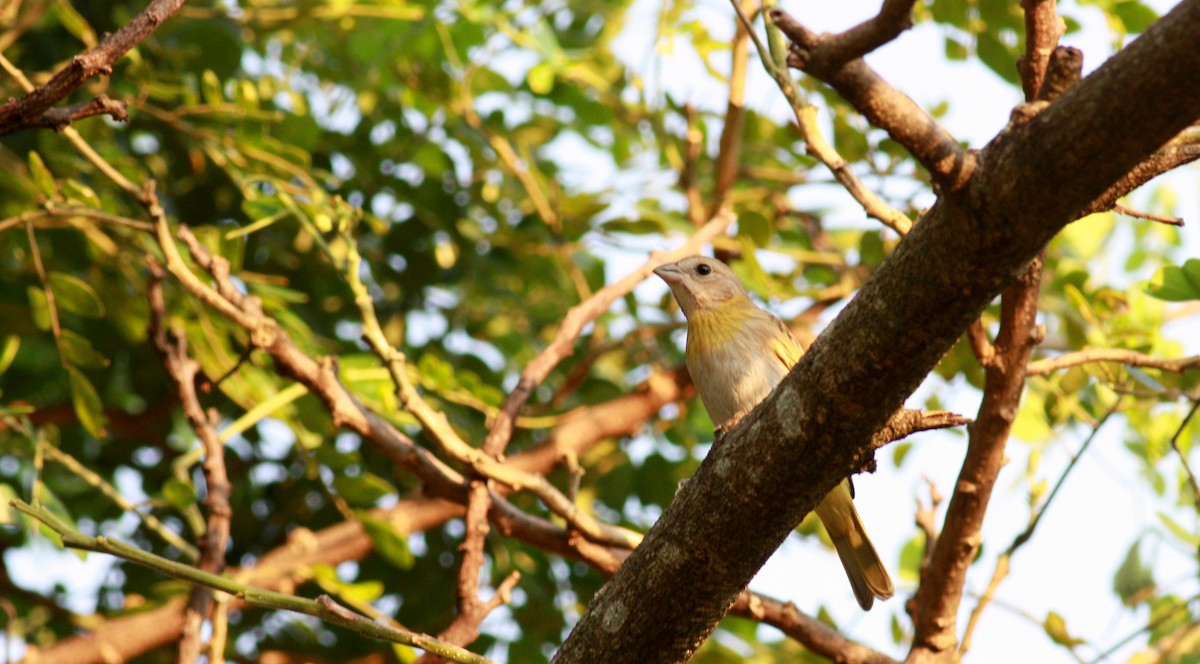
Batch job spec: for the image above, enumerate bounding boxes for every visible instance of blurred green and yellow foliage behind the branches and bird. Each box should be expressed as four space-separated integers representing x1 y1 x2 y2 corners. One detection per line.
0 0 1200 662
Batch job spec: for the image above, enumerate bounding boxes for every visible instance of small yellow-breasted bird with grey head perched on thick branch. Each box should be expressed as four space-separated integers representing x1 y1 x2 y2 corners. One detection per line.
654 256 894 611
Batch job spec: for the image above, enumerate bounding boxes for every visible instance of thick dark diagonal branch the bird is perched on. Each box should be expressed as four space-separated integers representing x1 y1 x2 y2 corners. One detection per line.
556 0 1200 663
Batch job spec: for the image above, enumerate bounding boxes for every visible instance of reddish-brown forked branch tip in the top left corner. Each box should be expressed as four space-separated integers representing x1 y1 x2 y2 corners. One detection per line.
0 0 184 136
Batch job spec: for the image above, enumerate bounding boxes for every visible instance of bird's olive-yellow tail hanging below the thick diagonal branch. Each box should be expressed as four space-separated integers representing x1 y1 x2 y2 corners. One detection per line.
817 479 895 611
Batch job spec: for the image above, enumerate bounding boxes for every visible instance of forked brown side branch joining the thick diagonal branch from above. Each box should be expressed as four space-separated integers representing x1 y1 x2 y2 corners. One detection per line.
770 5 976 191
